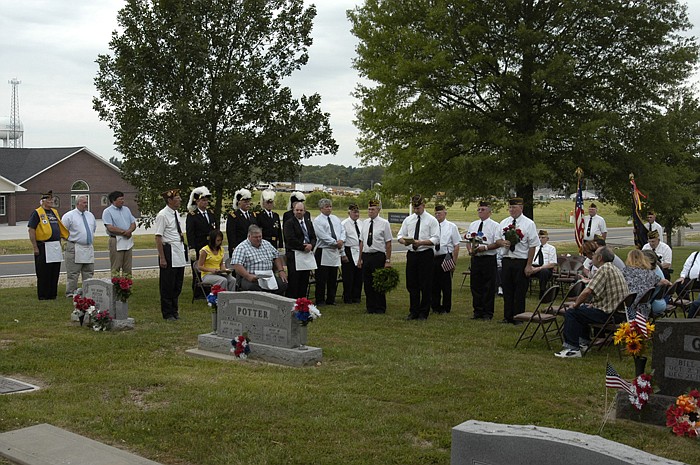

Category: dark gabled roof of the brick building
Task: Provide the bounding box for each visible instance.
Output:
[0,147,119,185]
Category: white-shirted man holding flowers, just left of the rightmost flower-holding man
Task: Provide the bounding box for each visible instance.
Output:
[464,201,501,321]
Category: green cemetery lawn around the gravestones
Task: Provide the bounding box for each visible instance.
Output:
[0,247,700,465]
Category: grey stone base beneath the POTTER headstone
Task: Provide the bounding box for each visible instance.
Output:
[187,333,323,367]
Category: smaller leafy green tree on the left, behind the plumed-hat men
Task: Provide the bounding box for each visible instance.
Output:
[93,0,337,225]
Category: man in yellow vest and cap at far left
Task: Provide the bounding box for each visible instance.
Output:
[27,191,68,300]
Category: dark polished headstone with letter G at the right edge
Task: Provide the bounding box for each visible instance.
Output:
[652,318,700,397]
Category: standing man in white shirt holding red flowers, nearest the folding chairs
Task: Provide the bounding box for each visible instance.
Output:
[496,197,540,325]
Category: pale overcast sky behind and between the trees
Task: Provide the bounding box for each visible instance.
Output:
[0,0,700,166]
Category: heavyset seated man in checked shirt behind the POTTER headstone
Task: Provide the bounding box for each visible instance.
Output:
[231,224,287,295]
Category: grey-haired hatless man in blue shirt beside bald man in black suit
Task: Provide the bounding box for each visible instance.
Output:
[314,199,347,307]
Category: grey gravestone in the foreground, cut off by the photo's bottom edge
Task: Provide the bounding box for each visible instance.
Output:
[450,420,681,465]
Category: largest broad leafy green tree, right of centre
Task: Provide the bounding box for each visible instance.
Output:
[348,0,698,217]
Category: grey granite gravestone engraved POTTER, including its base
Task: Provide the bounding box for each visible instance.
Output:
[188,291,323,366]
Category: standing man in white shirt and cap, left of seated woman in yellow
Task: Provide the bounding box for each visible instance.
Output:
[153,189,187,321]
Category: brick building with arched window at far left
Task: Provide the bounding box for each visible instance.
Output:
[0,147,140,226]
